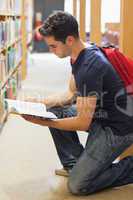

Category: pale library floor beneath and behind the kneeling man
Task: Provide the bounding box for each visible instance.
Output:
[0,54,133,200]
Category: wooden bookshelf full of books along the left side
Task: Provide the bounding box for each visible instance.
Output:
[0,0,33,129]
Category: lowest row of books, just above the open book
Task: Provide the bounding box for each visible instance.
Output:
[0,68,21,119]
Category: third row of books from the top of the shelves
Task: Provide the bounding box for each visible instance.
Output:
[0,43,22,87]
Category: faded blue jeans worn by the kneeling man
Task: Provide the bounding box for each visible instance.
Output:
[49,106,133,195]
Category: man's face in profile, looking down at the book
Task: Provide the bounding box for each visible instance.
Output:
[44,36,71,58]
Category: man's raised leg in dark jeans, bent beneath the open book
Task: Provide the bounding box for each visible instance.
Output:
[48,106,83,169]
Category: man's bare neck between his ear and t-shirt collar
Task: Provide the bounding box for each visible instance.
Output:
[71,40,86,62]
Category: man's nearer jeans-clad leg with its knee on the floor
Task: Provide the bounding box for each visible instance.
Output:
[68,123,133,195]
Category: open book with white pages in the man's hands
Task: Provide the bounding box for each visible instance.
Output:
[5,99,57,119]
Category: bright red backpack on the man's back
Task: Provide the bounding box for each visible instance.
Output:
[100,47,133,95]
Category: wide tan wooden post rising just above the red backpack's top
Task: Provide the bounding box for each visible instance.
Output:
[90,0,102,45]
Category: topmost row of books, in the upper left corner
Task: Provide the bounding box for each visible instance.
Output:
[0,0,22,15]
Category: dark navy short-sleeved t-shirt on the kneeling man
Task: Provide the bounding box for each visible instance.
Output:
[71,45,133,135]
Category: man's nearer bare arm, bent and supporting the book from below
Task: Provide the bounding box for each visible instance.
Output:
[22,96,97,131]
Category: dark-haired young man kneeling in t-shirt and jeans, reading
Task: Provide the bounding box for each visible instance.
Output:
[23,11,133,195]
